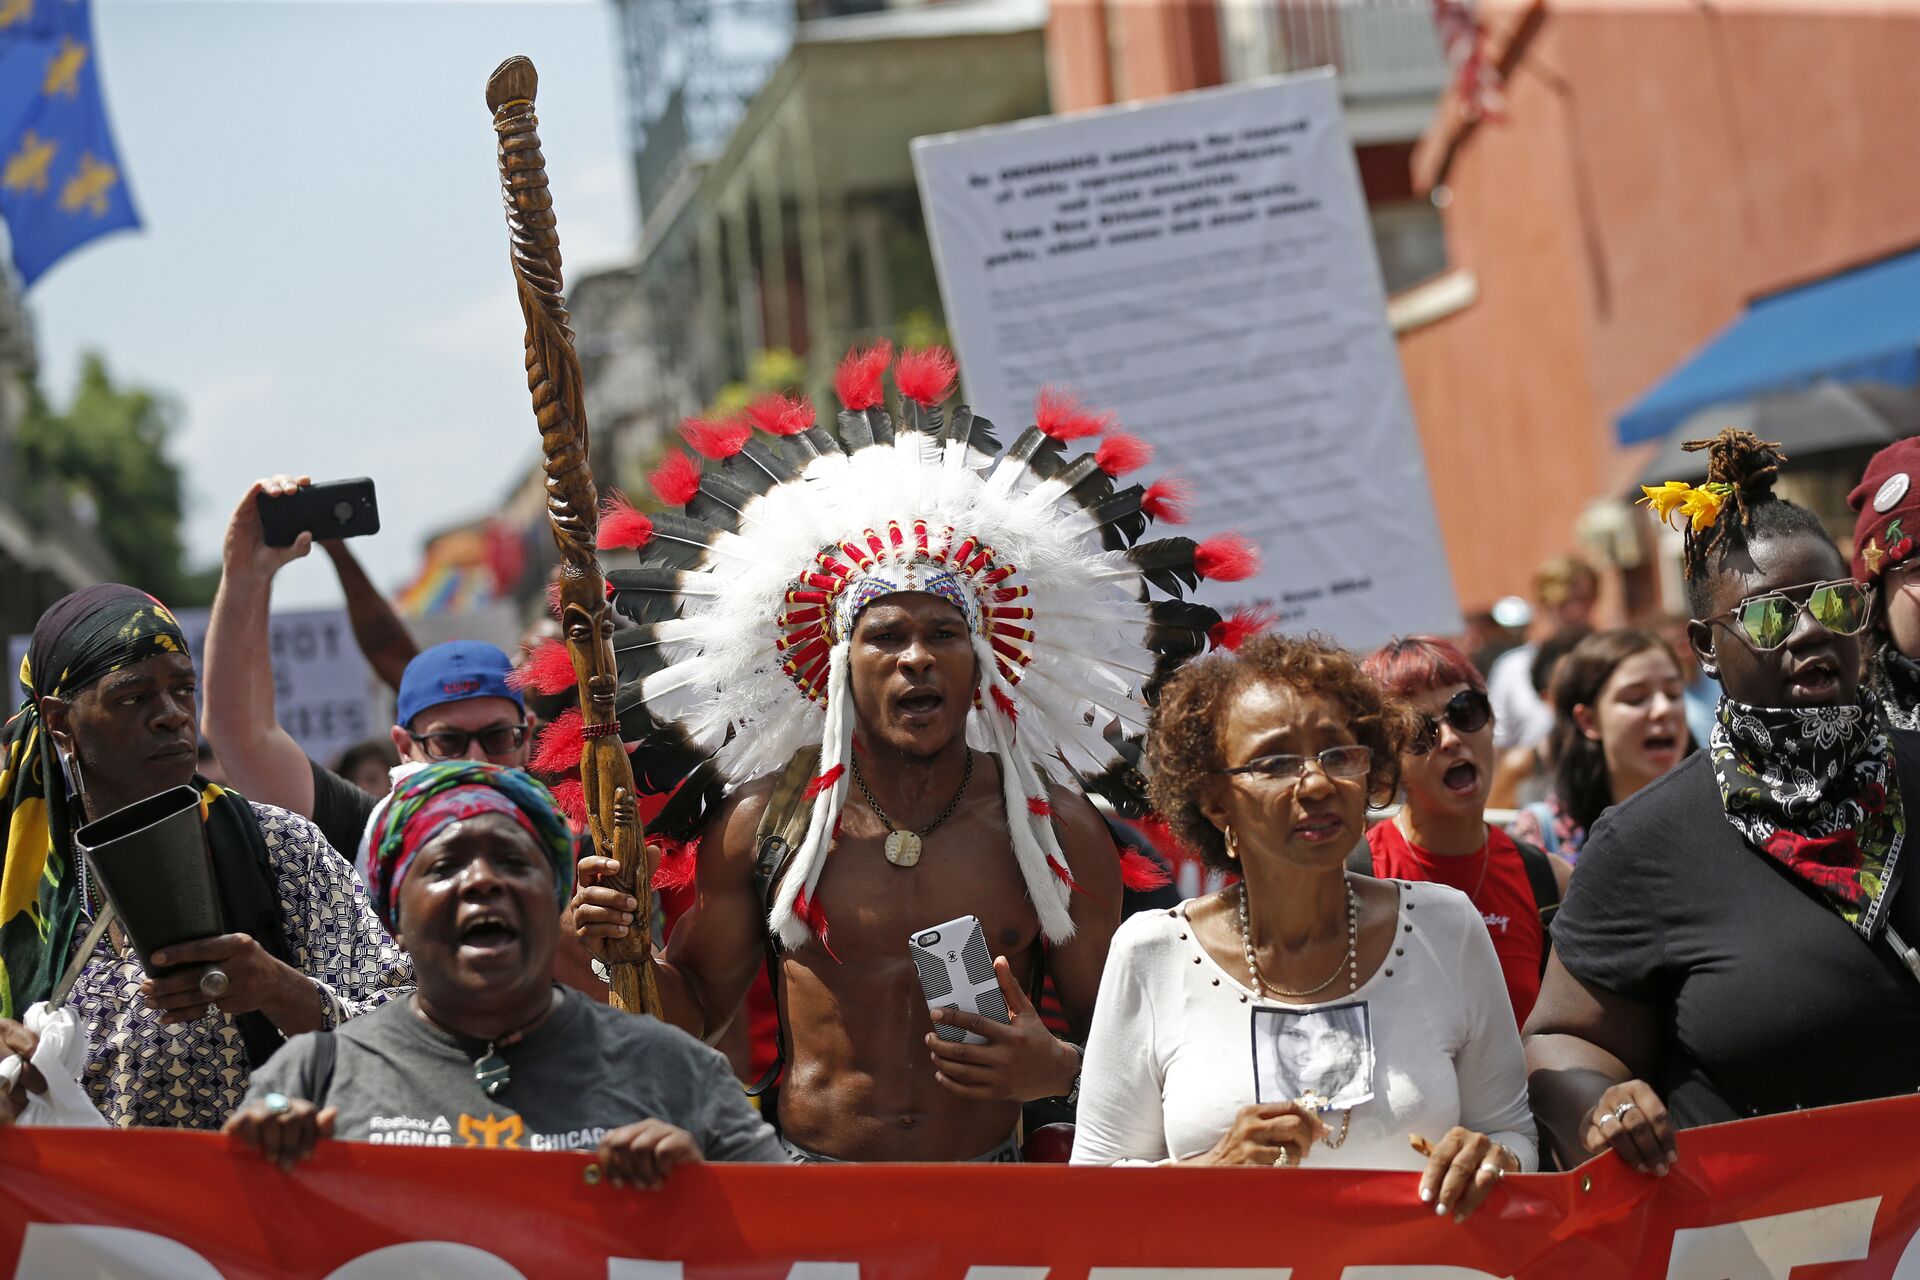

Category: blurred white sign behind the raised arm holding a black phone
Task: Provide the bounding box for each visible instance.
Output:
[8,608,386,764]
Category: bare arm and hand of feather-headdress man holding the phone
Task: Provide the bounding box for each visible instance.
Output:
[927,787,1121,1102]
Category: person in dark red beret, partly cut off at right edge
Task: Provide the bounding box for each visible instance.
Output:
[1847,438,1920,729]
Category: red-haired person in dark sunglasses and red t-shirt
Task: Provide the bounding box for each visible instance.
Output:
[1348,635,1572,1027]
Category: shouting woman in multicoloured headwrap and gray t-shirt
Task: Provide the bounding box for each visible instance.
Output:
[227,762,785,1186]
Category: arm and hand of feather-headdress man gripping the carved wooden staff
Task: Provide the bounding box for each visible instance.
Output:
[574,777,778,1044]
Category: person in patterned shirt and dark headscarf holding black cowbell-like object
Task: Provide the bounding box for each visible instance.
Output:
[0,583,411,1128]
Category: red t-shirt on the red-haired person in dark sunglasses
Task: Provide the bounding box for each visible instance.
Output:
[1367,821,1546,1027]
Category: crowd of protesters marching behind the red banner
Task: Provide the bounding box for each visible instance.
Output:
[0,430,1920,1219]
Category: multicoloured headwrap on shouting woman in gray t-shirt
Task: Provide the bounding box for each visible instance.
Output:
[367,760,574,929]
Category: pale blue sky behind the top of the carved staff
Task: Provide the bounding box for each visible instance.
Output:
[27,0,637,606]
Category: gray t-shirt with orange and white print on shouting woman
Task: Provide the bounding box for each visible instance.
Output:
[246,988,787,1163]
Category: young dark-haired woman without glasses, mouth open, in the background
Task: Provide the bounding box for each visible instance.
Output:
[1509,628,1692,862]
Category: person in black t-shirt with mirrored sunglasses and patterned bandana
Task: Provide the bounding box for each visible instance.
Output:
[1526,430,1920,1174]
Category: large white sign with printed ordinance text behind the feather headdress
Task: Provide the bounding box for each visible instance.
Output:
[914,71,1451,649]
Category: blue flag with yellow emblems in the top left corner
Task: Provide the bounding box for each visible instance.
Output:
[0,0,140,284]
